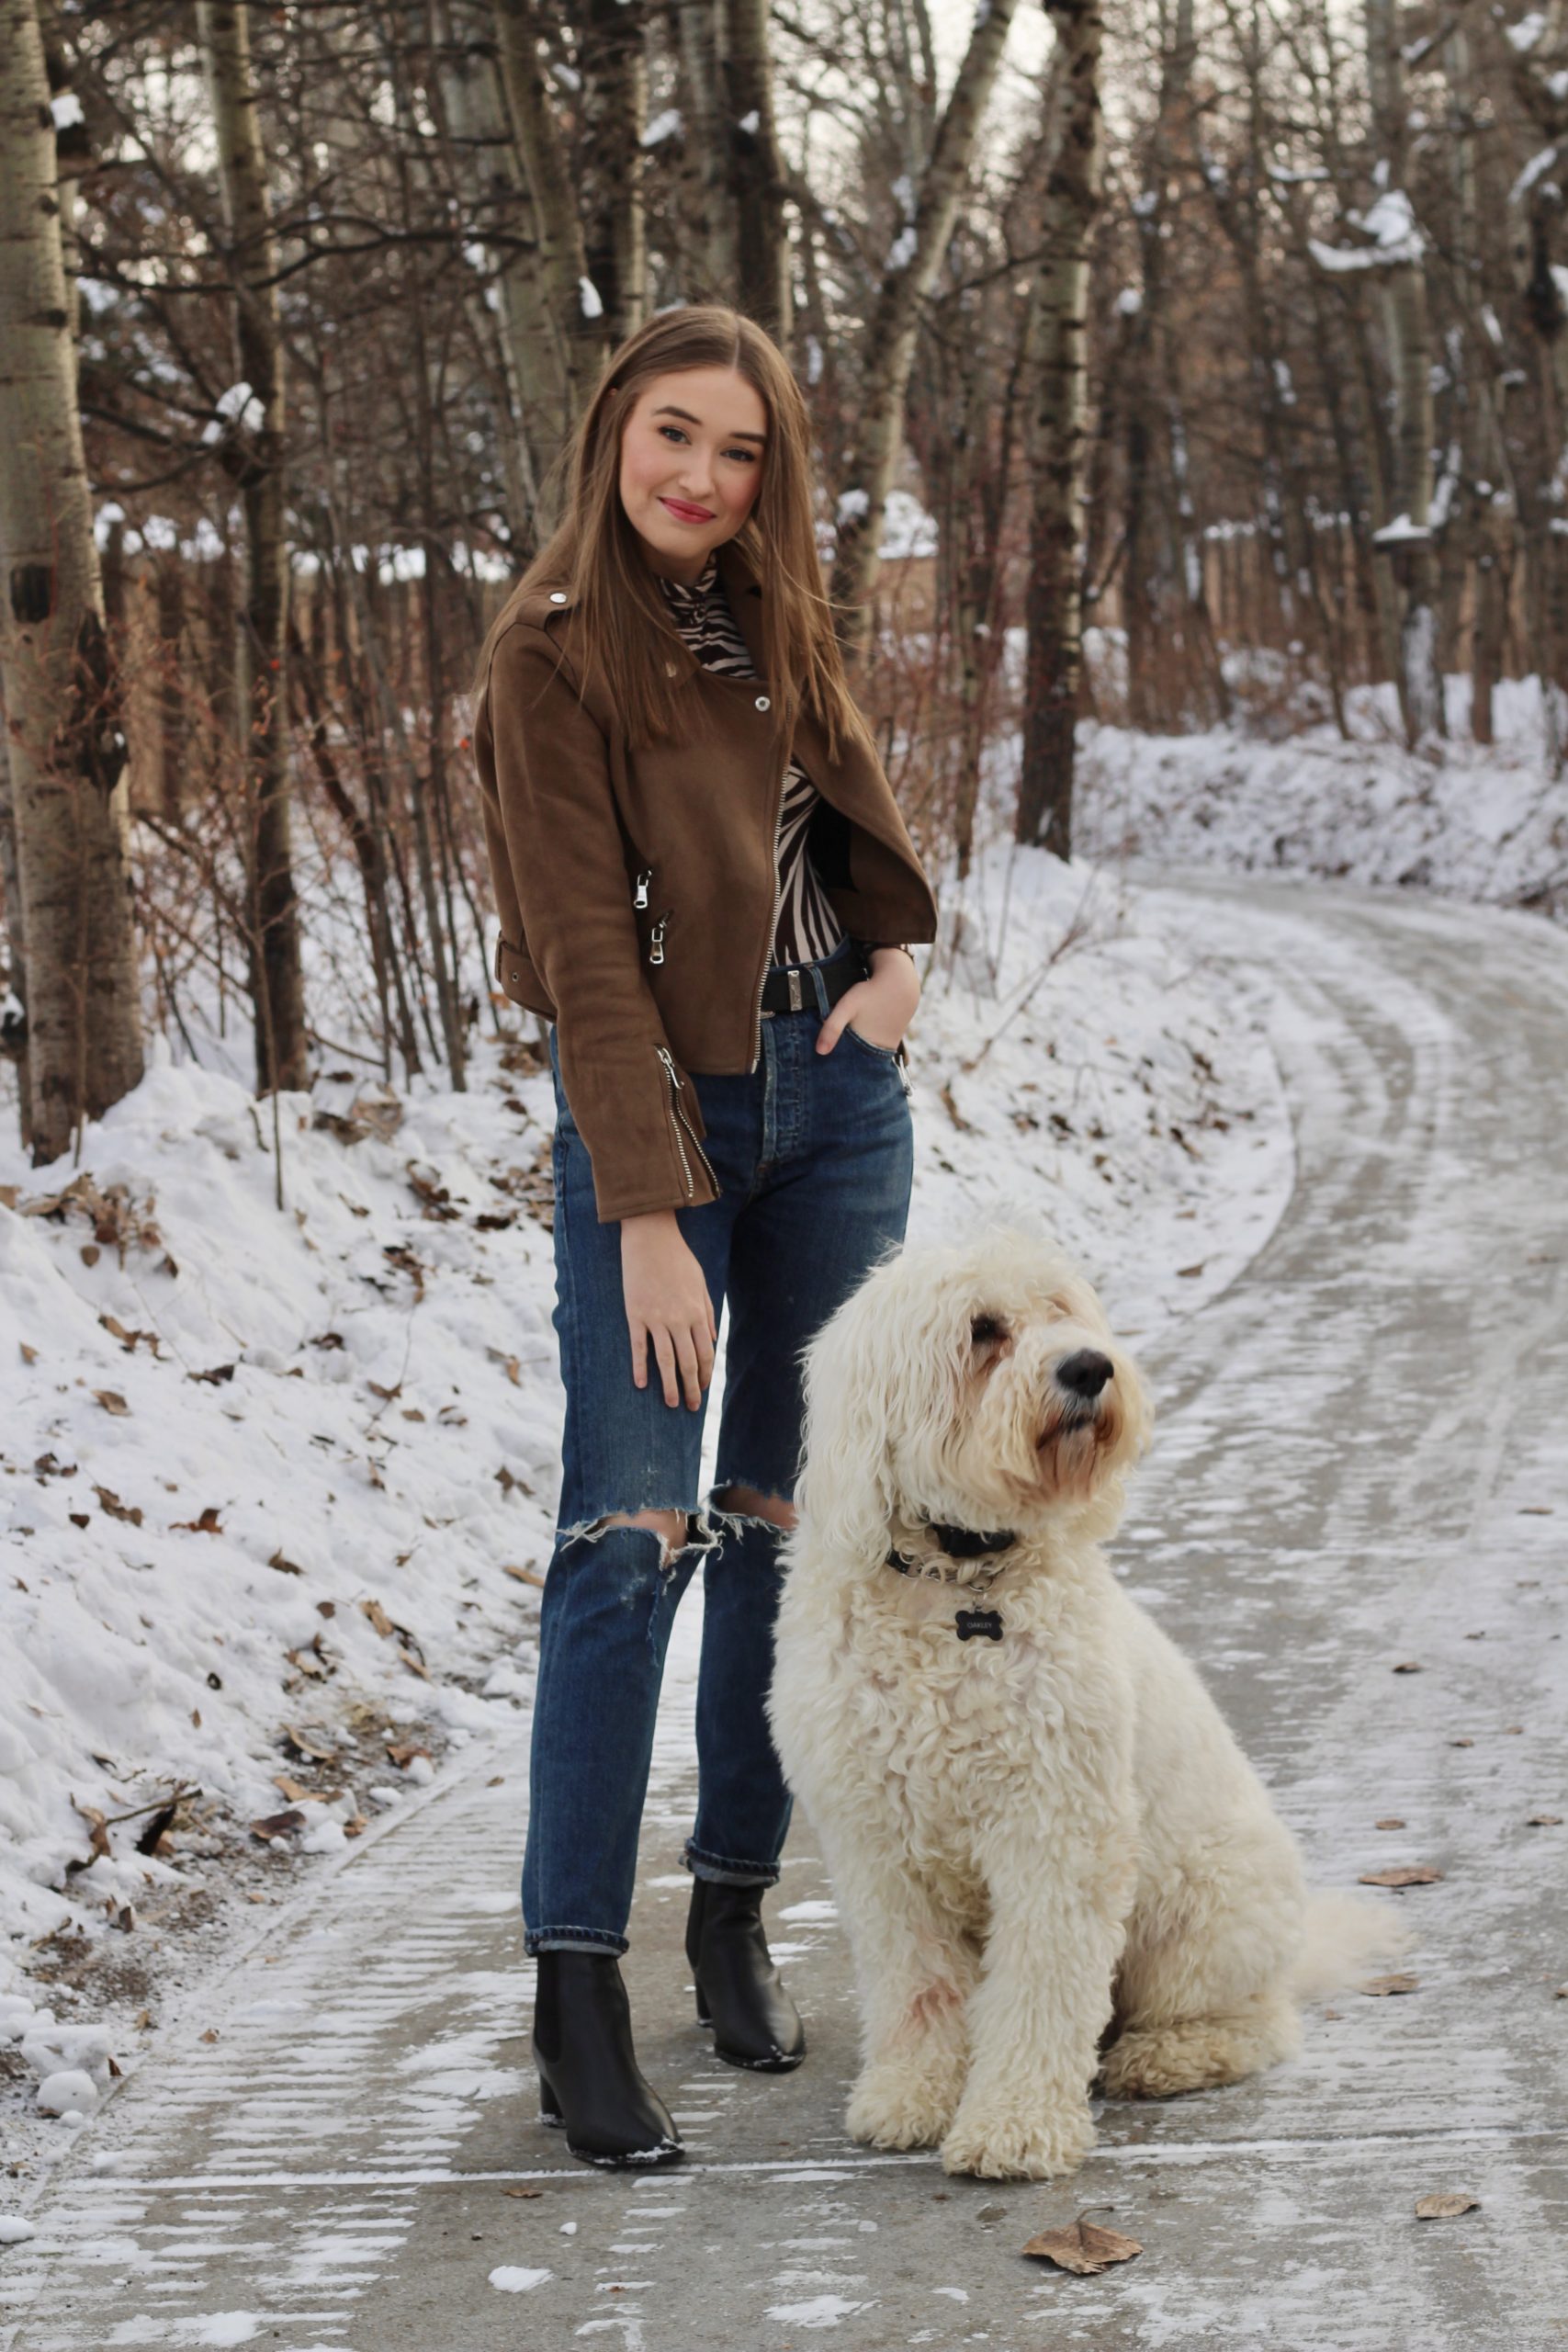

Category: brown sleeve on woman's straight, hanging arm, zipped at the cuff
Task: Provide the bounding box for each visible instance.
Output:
[487,621,717,1223]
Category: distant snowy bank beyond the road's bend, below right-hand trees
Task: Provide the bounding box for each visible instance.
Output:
[1075,656,1568,915]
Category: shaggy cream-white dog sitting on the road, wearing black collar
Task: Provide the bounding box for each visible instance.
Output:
[769,1230,1396,2180]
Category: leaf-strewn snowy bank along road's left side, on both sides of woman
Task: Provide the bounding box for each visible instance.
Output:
[0,847,1291,2159]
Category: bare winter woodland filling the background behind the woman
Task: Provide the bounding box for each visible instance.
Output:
[0,0,1568,1162]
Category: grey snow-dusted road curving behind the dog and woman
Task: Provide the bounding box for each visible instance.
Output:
[0,879,1568,2352]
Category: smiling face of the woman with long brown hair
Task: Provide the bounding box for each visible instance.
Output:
[621,367,766,585]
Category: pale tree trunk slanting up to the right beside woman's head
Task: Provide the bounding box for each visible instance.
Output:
[832,0,1024,651]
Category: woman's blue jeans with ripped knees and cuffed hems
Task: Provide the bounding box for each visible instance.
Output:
[522,941,915,1952]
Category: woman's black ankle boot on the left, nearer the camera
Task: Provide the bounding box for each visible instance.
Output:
[534,1952,686,2166]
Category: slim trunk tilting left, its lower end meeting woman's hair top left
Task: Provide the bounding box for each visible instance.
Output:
[491,0,606,425]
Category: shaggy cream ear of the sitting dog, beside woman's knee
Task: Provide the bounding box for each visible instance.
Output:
[795,1268,908,1574]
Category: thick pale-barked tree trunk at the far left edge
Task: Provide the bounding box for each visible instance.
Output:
[0,0,141,1159]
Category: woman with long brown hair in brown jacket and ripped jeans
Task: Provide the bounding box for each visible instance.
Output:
[475,308,936,2164]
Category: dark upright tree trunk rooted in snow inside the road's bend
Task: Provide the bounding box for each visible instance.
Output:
[1016,0,1105,858]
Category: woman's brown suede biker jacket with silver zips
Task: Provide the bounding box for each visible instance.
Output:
[475,546,936,1223]
